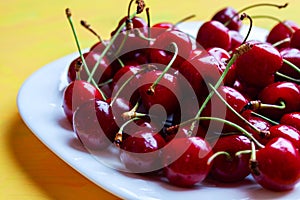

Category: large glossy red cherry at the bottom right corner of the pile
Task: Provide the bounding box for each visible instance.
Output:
[251,137,300,191]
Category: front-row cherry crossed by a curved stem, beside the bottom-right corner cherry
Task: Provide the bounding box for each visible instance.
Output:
[210,135,251,182]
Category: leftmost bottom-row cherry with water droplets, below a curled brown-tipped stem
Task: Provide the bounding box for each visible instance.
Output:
[120,129,165,173]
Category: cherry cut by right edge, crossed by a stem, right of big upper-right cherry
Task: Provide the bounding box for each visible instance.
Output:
[276,48,300,81]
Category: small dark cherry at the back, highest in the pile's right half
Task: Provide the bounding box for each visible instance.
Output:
[212,7,242,31]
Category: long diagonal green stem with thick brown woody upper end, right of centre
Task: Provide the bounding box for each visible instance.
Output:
[190,43,252,131]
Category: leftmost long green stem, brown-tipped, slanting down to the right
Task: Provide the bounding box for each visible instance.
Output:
[65,8,106,100]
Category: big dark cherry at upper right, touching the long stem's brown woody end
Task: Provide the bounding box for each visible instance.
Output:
[236,42,283,88]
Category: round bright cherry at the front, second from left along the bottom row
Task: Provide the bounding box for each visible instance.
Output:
[163,137,212,187]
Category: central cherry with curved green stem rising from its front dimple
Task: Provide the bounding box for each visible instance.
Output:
[139,70,182,114]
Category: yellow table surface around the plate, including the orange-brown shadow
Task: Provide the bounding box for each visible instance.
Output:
[0,0,300,200]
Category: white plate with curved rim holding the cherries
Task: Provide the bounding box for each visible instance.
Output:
[17,22,300,200]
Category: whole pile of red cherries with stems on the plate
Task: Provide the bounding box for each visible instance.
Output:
[63,0,300,191]
